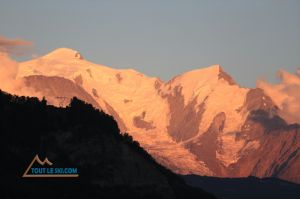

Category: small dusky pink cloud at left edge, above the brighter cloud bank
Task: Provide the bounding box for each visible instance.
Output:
[0,35,32,56]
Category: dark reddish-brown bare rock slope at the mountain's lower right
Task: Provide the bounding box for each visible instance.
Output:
[227,121,300,183]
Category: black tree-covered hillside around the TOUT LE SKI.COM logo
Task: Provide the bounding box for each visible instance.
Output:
[0,91,214,199]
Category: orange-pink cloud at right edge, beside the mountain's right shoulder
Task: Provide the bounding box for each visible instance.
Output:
[257,69,300,124]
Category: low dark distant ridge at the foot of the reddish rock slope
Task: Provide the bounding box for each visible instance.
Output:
[184,175,300,199]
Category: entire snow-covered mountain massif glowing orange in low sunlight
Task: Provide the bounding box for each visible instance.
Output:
[18,48,300,182]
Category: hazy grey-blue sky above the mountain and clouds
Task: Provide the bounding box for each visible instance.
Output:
[0,0,300,86]
